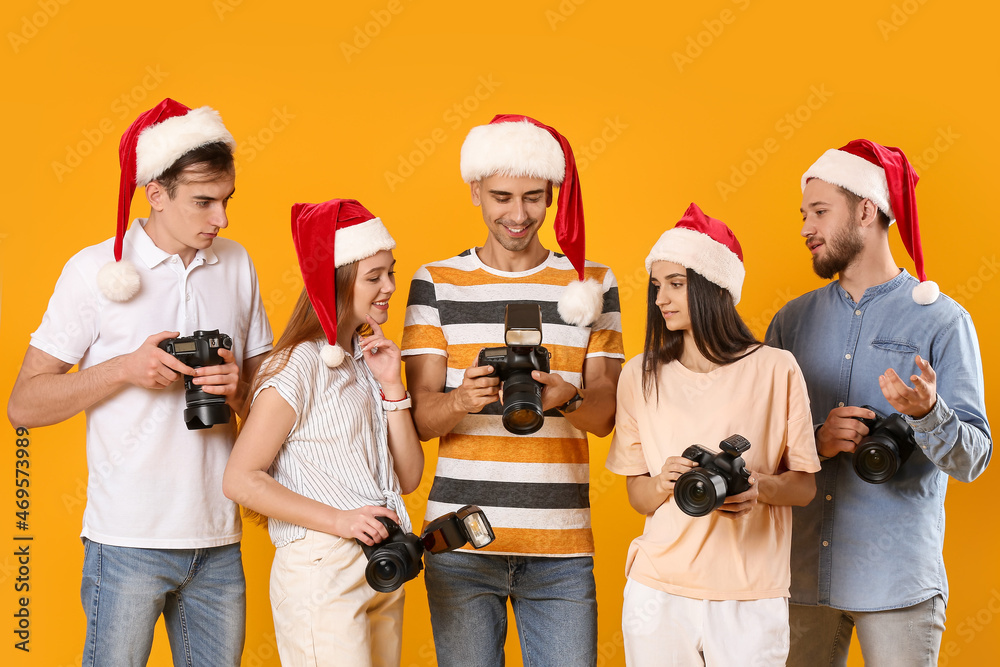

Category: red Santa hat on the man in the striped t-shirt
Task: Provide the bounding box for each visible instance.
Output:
[460,114,604,326]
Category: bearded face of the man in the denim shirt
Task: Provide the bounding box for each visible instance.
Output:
[800,178,864,280]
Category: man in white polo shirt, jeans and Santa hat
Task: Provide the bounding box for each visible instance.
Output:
[7,99,272,665]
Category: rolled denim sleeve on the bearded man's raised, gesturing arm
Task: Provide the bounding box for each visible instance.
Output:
[906,309,993,482]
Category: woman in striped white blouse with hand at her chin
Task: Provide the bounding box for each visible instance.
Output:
[223,200,424,666]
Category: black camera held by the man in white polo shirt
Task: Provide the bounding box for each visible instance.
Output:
[160,329,233,431]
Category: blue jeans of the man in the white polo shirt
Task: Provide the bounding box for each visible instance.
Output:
[80,538,246,667]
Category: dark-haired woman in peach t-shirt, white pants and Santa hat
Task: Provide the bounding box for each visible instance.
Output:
[607,204,819,667]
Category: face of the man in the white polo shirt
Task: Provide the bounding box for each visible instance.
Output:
[145,165,236,265]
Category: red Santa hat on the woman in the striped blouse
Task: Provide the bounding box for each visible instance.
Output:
[292,199,396,368]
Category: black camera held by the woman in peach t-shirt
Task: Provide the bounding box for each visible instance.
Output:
[674,434,750,516]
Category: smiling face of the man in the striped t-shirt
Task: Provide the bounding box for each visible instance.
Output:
[472,174,552,252]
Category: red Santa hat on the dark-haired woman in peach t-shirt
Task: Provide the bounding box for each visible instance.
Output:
[646,203,746,305]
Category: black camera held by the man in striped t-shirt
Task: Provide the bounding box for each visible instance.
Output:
[476,303,552,435]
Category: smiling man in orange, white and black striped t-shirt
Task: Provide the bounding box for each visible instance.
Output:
[403,116,624,667]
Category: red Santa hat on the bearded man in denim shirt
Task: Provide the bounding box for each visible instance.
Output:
[802,139,941,306]
